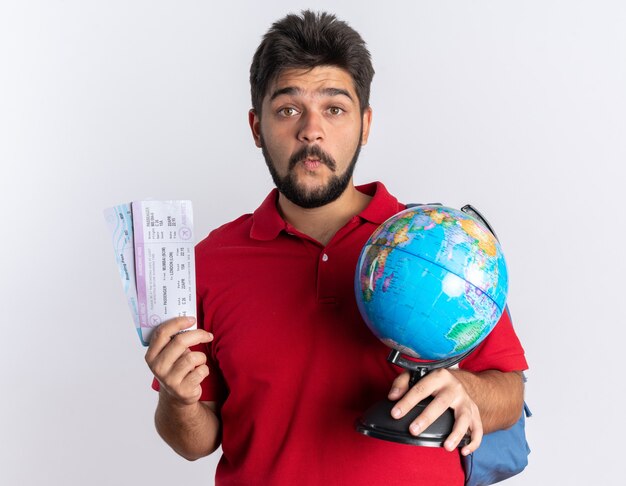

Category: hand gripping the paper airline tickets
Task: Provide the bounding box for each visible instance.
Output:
[146,317,213,405]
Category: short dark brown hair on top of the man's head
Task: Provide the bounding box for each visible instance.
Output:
[250,10,374,115]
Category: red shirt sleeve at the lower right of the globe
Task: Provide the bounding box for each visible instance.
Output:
[459,307,528,372]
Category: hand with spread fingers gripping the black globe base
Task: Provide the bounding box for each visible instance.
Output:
[389,368,483,456]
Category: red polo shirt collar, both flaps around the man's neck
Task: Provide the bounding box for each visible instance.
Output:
[250,182,402,241]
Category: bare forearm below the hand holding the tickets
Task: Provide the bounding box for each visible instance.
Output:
[155,391,220,461]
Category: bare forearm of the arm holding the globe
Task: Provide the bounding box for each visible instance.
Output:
[450,370,524,434]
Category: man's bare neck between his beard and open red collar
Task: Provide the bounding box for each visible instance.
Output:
[278,181,371,246]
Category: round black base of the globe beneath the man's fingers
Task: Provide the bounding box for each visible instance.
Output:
[356,397,470,447]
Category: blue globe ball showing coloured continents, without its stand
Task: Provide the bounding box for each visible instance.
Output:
[355,205,508,360]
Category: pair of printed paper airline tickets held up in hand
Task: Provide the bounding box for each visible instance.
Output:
[104,200,196,346]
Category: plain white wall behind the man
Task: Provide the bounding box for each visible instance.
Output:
[0,0,626,486]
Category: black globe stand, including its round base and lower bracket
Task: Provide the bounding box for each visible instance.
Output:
[355,349,474,447]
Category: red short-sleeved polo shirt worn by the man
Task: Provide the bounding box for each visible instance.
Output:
[154,183,527,486]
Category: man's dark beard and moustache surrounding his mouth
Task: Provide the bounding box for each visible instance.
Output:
[261,132,363,209]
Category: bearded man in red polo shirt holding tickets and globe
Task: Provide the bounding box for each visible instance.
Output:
[146,11,527,486]
